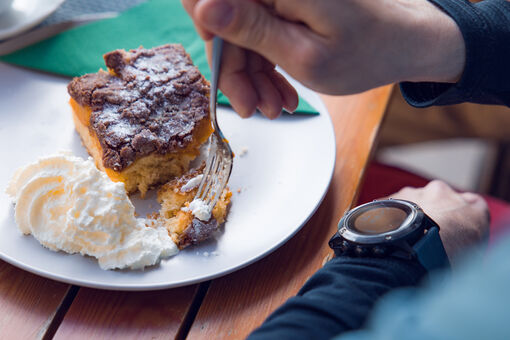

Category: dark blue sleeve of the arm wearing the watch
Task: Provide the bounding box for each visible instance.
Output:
[248,257,426,340]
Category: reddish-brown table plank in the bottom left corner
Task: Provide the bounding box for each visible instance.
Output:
[0,260,70,339]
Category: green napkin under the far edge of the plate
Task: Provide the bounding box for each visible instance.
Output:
[0,0,317,114]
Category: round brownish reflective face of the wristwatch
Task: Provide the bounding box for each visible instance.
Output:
[351,207,409,235]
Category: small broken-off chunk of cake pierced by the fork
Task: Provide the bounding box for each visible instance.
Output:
[158,168,232,249]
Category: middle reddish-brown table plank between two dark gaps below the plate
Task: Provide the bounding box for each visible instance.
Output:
[54,285,199,340]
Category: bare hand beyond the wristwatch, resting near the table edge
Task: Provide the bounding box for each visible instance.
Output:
[390,180,490,265]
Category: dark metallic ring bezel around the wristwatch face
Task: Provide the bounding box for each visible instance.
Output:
[338,199,425,245]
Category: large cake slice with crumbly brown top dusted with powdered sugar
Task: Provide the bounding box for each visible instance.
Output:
[68,45,212,196]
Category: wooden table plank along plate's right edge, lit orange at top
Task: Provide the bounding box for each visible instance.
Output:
[188,86,392,340]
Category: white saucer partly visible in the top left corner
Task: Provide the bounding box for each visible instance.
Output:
[0,0,64,40]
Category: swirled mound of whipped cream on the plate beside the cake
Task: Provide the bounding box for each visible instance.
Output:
[6,153,178,269]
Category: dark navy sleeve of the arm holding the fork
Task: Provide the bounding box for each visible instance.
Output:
[400,0,510,107]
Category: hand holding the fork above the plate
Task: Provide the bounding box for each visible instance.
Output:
[182,0,465,118]
